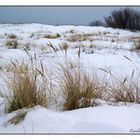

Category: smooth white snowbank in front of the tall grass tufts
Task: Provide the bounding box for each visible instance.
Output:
[0,104,140,133]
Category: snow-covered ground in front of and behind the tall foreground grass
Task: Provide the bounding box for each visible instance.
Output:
[0,24,140,133]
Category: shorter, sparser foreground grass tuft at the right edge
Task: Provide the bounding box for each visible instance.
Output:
[110,77,140,103]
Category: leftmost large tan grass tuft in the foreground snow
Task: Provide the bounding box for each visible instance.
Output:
[3,57,51,112]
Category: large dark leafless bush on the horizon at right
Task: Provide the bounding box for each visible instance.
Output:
[105,8,140,31]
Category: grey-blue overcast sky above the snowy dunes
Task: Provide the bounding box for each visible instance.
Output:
[0,7,140,25]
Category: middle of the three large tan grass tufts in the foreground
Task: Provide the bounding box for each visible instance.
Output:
[59,62,104,110]
